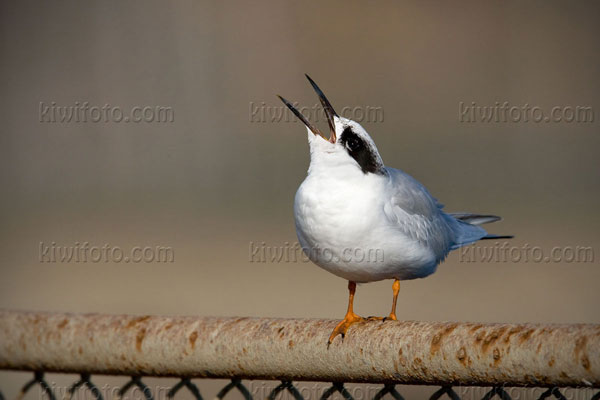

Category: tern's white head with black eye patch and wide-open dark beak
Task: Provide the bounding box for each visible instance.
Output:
[278,75,385,175]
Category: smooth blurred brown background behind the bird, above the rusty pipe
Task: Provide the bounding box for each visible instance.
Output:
[0,1,600,393]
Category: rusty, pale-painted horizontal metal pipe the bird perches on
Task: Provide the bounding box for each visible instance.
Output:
[0,311,600,387]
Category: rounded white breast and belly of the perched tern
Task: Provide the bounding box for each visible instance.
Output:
[294,170,438,282]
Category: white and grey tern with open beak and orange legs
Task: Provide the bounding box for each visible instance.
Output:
[277,75,513,346]
